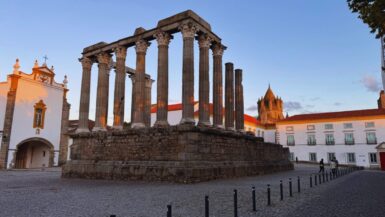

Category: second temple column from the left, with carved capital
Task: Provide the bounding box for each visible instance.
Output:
[93,52,111,131]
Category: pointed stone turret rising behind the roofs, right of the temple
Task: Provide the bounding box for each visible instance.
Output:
[258,85,284,124]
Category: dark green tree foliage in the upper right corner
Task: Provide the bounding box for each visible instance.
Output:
[347,0,385,38]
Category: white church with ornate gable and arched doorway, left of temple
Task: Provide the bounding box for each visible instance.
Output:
[0,60,70,169]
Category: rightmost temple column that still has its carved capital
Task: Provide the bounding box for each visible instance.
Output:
[211,43,226,128]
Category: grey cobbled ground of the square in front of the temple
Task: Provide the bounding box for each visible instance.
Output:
[0,165,376,217]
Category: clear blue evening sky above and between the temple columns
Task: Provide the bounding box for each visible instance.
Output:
[0,0,381,121]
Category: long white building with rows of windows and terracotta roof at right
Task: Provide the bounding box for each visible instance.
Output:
[276,97,385,168]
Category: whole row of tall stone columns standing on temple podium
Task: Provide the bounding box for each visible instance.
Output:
[78,23,243,132]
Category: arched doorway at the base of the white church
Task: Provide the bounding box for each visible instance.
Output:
[14,138,54,169]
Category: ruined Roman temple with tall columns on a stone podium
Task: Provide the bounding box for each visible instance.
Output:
[62,10,293,183]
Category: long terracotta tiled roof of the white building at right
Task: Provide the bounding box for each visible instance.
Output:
[278,109,385,123]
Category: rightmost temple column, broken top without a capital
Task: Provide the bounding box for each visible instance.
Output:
[235,69,245,132]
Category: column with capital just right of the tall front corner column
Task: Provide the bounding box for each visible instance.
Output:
[197,34,212,126]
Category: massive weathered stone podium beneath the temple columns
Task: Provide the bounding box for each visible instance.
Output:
[63,125,293,183]
